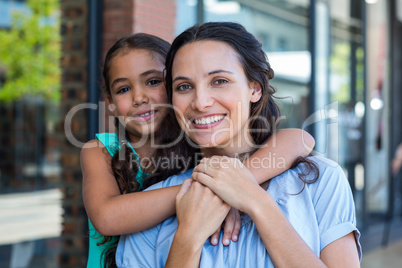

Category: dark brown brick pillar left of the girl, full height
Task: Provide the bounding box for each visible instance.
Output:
[57,0,88,267]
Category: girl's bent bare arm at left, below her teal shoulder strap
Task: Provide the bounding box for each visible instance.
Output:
[81,140,180,236]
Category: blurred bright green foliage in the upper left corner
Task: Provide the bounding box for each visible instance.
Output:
[0,0,61,102]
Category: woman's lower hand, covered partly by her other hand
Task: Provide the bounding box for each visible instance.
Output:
[176,179,230,245]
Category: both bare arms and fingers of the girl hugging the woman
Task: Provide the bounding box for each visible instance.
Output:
[81,129,314,236]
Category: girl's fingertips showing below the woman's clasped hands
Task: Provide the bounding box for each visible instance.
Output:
[211,208,241,246]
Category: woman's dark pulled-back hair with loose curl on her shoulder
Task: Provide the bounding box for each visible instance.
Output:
[165,22,319,186]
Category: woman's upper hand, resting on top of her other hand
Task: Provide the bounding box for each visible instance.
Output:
[192,156,264,213]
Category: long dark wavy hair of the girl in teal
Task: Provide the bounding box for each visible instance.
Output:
[101,33,195,267]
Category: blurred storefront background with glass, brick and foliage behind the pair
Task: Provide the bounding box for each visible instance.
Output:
[0,0,402,267]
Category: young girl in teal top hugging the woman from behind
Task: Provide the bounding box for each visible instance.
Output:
[81,34,314,267]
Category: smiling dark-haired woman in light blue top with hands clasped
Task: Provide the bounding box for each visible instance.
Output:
[116,23,360,267]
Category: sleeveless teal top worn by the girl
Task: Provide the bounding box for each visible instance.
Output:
[87,133,145,268]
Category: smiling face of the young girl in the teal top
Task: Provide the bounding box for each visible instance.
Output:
[108,49,167,142]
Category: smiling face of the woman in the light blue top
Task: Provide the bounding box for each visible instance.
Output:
[172,41,261,155]
